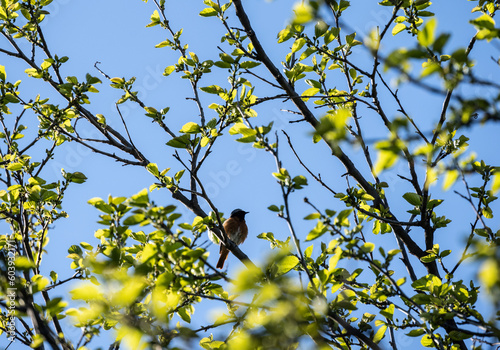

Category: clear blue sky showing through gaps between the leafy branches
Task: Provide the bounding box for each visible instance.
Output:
[0,0,499,349]
